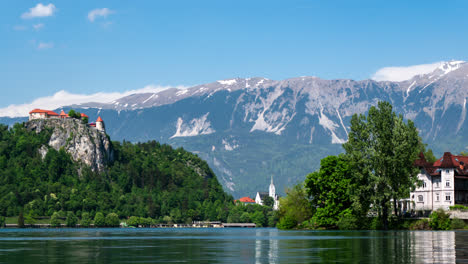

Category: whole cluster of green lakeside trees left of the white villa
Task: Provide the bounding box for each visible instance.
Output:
[278,102,435,229]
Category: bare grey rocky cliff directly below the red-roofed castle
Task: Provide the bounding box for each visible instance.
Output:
[25,118,114,171]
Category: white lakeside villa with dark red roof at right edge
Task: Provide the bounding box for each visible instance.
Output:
[410,152,468,212]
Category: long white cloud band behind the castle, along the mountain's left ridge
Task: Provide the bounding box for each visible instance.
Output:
[0,85,188,117]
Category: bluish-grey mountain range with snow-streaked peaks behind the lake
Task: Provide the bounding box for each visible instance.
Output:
[0,61,468,198]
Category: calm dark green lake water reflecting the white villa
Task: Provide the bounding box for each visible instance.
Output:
[0,228,468,263]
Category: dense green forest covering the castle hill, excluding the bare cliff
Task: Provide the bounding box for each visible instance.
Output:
[0,124,276,226]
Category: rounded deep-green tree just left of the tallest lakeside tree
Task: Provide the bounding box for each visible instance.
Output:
[305,155,352,228]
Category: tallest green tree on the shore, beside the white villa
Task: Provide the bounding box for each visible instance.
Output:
[343,102,423,229]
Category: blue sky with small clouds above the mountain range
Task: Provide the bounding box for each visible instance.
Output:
[0,0,468,116]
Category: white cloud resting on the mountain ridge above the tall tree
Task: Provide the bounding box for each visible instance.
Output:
[371,62,444,82]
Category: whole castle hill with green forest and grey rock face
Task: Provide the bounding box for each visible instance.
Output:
[0,119,232,222]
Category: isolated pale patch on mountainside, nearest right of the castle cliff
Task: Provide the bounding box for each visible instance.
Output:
[170,112,216,138]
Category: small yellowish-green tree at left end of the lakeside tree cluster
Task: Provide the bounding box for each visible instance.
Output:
[278,184,312,228]
